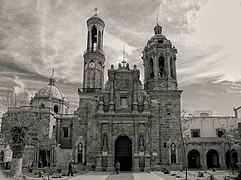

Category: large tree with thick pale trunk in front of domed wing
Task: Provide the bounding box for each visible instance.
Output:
[1,89,45,176]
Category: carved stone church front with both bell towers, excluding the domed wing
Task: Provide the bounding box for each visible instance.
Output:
[72,14,183,171]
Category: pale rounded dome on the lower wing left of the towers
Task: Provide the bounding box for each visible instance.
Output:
[35,78,65,99]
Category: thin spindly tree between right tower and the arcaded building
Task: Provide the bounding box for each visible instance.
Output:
[178,110,193,180]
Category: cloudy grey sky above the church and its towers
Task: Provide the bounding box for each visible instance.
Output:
[0,0,241,116]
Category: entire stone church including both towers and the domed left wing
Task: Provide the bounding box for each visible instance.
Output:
[0,14,183,171]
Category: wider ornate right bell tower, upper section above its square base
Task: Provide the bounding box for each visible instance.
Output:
[142,23,177,90]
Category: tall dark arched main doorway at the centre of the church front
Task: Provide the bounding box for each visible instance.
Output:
[115,136,132,171]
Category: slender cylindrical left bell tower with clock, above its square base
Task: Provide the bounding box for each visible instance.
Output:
[83,8,105,92]
